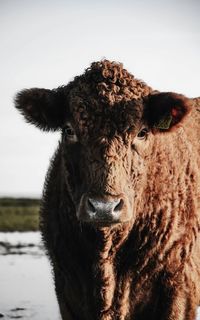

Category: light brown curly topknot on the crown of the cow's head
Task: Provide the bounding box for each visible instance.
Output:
[69,60,152,106]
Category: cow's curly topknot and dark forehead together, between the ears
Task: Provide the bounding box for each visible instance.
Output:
[65,60,152,139]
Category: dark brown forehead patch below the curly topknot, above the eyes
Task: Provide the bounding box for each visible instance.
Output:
[70,97,144,137]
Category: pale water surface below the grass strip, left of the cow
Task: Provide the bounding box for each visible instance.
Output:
[0,232,60,320]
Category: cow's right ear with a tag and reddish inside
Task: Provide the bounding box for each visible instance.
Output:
[145,92,193,133]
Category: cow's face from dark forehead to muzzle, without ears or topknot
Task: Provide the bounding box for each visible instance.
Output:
[62,96,150,224]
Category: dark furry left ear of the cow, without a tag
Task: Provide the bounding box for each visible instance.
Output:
[15,87,68,131]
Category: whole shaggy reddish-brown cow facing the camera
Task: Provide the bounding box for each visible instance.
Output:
[15,60,200,320]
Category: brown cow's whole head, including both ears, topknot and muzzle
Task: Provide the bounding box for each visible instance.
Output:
[16,60,191,225]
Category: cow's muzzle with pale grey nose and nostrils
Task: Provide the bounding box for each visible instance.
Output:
[77,194,131,225]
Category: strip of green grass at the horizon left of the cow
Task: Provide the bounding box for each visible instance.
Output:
[0,198,40,231]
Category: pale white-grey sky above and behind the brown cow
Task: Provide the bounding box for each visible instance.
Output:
[0,0,200,196]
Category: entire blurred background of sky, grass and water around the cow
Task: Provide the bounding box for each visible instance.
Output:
[0,0,200,320]
